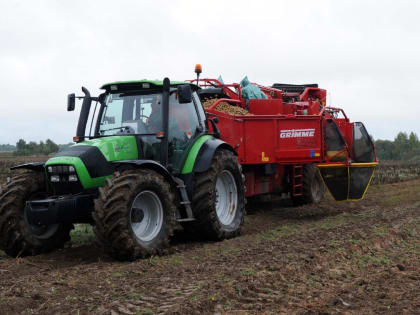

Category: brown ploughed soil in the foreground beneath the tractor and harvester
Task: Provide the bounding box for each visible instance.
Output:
[0,157,420,314]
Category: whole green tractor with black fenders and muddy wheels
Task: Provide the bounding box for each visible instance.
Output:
[0,78,245,260]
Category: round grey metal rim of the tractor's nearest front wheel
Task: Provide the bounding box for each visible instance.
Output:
[130,190,163,242]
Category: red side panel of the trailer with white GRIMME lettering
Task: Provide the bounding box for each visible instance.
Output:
[207,111,323,164]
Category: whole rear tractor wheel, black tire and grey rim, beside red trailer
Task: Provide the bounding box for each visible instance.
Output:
[186,150,245,240]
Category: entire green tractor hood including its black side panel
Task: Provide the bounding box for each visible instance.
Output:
[46,136,138,189]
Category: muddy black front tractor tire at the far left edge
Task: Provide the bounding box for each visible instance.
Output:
[0,171,73,257]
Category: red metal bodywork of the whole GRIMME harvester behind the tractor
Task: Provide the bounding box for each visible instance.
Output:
[191,79,370,197]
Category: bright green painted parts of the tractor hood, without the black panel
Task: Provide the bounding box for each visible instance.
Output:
[45,136,139,189]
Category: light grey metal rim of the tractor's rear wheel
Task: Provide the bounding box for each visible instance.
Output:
[216,170,238,225]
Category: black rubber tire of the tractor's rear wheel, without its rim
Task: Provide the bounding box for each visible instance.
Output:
[184,150,245,241]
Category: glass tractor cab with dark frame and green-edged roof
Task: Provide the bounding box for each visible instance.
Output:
[70,80,207,173]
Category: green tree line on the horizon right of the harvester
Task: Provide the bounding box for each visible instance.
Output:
[375,132,420,161]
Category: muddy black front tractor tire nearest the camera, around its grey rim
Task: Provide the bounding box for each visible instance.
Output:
[93,169,176,260]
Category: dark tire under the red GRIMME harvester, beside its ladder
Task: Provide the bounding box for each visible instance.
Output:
[292,164,325,206]
